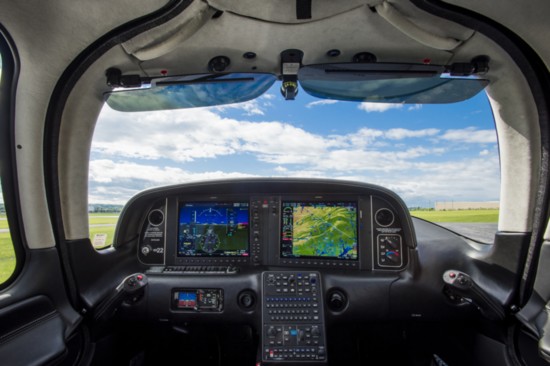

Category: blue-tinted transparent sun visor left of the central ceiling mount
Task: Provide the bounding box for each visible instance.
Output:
[105,73,277,112]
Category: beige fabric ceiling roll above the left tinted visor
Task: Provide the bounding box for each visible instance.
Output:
[122,1,216,61]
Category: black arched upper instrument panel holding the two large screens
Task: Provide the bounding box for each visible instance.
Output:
[117,179,416,271]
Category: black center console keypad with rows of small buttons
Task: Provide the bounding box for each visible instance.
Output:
[262,271,327,363]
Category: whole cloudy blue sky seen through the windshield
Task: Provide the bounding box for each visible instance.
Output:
[89,82,500,207]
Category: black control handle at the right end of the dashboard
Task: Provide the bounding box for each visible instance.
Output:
[443,269,506,320]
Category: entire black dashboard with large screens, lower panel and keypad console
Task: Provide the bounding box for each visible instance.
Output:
[110,179,489,364]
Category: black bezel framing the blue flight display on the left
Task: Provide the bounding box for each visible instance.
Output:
[175,199,251,262]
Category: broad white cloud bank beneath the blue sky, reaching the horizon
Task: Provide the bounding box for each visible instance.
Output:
[90,104,499,203]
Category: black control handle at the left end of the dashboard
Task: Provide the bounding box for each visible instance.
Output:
[94,273,148,321]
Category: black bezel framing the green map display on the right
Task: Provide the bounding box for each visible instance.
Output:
[278,197,361,263]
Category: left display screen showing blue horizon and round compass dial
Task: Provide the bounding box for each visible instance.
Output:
[177,202,249,257]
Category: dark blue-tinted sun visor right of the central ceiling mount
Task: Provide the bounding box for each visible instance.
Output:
[298,63,489,104]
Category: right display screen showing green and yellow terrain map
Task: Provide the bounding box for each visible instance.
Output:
[281,201,357,260]
